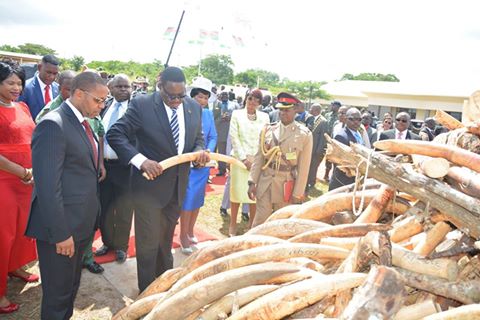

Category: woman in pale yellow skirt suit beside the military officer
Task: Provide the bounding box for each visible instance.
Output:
[228,89,270,236]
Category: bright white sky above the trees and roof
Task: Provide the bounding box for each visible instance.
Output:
[0,0,480,87]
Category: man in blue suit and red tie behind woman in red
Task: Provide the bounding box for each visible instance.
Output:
[18,54,60,120]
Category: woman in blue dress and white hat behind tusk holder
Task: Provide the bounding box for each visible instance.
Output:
[180,77,217,255]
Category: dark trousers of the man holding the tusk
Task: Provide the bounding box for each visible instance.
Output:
[135,190,181,292]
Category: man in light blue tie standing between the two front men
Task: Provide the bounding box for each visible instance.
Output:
[95,74,133,263]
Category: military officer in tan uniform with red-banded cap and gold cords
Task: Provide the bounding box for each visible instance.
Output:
[248,92,313,226]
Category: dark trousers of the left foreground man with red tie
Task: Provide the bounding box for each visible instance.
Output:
[37,234,93,320]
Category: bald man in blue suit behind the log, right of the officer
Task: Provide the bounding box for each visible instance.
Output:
[328,108,365,190]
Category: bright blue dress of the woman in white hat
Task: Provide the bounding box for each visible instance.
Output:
[182,108,217,211]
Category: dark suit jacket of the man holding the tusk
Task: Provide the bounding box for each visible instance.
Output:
[107,92,204,208]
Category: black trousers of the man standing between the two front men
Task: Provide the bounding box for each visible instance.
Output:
[100,161,133,251]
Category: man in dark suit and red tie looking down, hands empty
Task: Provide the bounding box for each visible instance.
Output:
[26,72,108,320]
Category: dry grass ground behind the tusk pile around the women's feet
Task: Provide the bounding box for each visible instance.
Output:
[196,182,328,239]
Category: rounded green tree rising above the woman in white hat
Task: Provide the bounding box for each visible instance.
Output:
[200,54,233,84]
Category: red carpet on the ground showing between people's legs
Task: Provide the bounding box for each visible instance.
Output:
[93,168,226,263]
